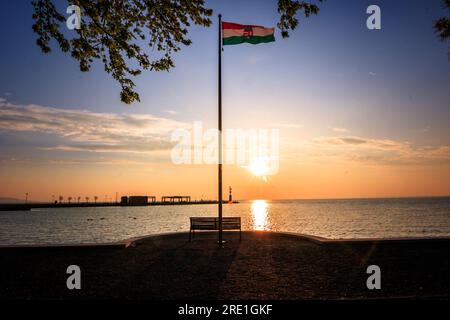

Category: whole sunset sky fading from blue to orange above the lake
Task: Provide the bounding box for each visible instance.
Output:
[0,1,450,201]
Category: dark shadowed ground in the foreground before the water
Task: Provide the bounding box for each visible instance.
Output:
[0,232,450,300]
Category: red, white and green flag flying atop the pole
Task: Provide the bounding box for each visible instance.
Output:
[222,22,275,46]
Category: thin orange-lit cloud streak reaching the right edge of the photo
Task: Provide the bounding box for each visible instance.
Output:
[313,136,450,165]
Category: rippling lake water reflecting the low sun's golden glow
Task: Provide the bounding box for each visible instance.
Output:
[0,198,450,245]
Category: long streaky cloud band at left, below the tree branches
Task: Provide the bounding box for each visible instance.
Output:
[0,99,189,153]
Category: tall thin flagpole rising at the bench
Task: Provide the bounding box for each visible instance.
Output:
[217,14,223,247]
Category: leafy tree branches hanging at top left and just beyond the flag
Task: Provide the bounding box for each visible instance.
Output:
[32,0,322,103]
